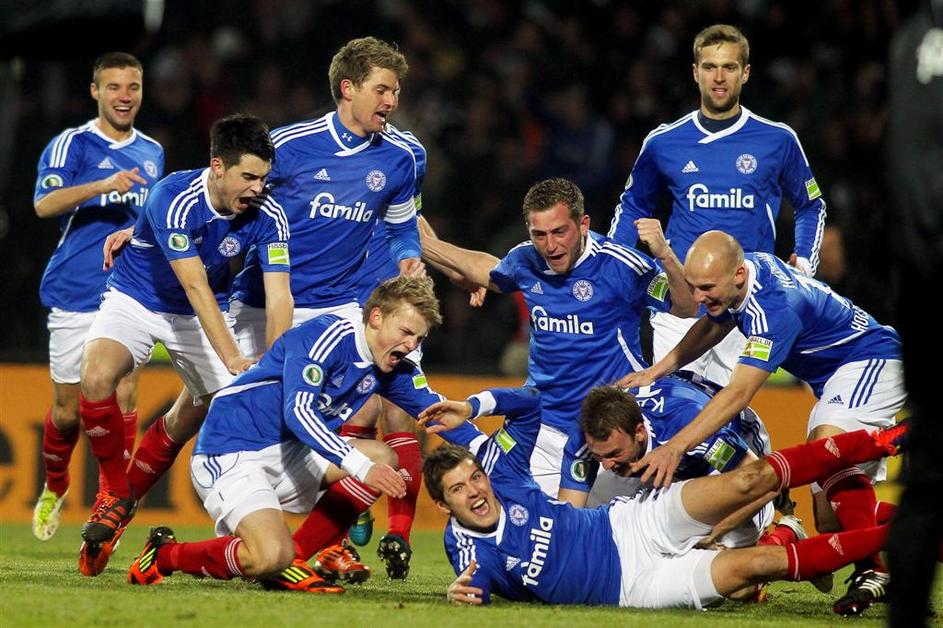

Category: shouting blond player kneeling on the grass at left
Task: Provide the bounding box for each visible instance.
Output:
[128,277,450,593]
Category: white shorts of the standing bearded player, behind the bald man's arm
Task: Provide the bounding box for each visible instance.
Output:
[651,312,747,386]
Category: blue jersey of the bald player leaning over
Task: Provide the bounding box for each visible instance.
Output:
[712,253,901,397]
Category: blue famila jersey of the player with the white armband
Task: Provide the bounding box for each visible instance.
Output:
[233,112,420,308]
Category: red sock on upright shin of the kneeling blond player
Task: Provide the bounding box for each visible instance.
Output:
[292,477,380,560]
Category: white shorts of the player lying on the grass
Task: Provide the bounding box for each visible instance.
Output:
[609,482,722,609]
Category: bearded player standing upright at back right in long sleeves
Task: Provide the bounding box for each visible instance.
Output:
[609,24,825,385]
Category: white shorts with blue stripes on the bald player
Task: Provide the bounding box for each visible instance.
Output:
[808,359,907,492]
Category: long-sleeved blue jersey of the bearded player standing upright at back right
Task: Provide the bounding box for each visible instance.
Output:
[609,107,825,273]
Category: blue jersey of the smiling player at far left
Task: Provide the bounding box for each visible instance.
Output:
[33,120,164,312]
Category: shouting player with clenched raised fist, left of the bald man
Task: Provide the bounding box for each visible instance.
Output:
[422,179,696,505]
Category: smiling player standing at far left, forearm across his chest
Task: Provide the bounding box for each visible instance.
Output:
[33,52,164,541]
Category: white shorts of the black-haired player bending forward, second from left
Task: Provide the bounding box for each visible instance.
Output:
[85,290,234,399]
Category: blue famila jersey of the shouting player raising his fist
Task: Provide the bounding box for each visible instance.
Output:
[491,232,671,432]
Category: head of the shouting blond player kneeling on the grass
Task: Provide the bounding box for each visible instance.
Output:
[363,275,442,373]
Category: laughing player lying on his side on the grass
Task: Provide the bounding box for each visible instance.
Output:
[421,395,907,609]
